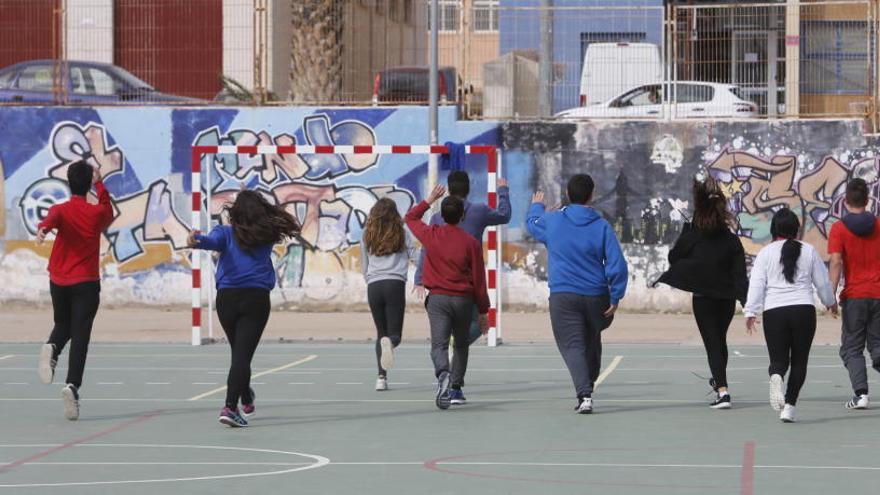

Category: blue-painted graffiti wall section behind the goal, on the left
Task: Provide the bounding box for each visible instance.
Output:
[0,108,502,306]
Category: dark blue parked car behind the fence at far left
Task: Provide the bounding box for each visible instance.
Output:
[0,60,201,104]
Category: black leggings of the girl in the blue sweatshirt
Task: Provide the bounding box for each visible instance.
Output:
[217,289,272,409]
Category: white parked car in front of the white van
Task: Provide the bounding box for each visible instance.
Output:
[556,81,758,119]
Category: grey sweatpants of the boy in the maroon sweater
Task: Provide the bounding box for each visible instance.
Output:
[425,294,474,387]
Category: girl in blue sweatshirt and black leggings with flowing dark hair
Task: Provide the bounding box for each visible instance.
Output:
[189,191,300,428]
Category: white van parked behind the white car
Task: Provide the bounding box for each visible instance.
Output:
[580,43,663,106]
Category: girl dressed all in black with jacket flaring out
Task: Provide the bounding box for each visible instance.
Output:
[655,178,749,409]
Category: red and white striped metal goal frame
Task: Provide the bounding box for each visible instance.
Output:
[190,145,502,347]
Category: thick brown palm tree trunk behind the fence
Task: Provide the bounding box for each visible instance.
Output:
[289,0,348,102]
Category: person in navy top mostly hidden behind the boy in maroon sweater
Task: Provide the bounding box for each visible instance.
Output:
[413,170,512,344]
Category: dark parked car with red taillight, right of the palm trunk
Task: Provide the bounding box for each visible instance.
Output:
[373,66,459,104]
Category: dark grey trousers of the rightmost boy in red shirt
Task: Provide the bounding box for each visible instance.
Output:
[840,299,880,393]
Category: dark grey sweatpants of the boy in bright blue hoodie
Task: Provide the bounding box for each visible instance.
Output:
[550,292,611,398]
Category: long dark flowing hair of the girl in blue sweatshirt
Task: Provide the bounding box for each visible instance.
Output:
[224,191,300,250]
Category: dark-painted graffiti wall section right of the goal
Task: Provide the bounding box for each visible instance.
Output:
[502,121,880,311]
